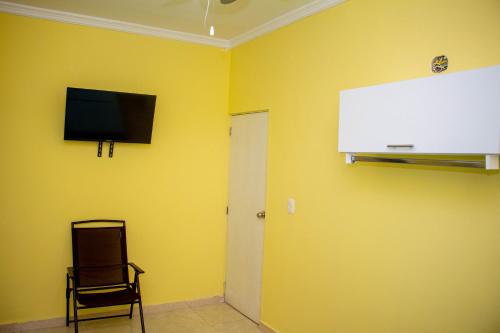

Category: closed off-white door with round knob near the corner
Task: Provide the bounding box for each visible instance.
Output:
[225,112,267,322]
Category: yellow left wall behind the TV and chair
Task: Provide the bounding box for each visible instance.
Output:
[0,14,230,324]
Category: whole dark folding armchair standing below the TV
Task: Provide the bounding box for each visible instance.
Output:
[66,220,145,333]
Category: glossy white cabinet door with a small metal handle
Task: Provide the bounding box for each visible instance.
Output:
[339,66,500,154]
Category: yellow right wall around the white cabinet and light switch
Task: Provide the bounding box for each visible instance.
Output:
[230,0,500,333]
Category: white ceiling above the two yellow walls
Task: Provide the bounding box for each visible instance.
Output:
[0,0,342,47]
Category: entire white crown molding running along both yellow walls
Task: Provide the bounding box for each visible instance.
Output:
[0,0,346,49]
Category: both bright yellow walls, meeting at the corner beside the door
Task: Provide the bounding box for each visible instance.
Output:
[0,0,500,333]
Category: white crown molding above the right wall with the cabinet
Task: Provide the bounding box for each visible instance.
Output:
[229,0,346,47]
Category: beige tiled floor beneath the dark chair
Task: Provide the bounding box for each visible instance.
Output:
[22,303,262,333]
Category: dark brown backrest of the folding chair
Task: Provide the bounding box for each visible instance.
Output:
[71,220,129,288]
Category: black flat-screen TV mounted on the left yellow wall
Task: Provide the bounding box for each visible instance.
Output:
[64,88,156,143]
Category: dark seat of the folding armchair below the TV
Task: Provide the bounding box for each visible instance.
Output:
[76,288,139,307]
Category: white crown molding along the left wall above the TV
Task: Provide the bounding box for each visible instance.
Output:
[0,1,230,48]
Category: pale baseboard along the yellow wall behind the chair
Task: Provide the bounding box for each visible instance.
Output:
[0,296,224,333]
